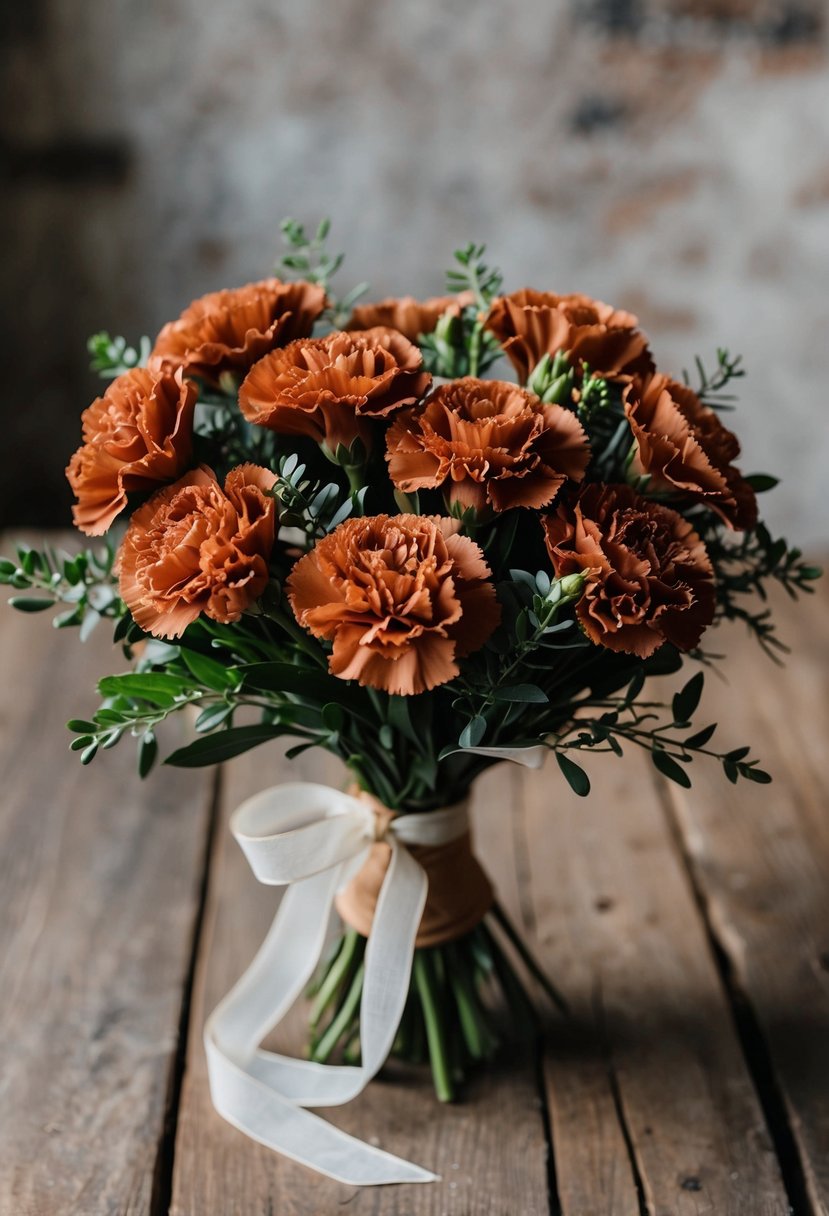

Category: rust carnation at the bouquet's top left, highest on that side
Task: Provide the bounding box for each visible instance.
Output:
[150,278,327,383]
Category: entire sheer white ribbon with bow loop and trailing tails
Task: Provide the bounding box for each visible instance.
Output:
[204,783,468,1186]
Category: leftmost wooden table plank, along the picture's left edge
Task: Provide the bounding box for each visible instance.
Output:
[0,586,216,1216]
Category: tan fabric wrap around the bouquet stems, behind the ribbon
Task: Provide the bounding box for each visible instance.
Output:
[337,790,495,946]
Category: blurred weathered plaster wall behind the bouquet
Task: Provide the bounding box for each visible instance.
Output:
[0,0,829,544]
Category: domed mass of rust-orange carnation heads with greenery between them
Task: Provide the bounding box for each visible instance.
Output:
[53,234,806,778]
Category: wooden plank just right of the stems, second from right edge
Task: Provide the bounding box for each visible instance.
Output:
[524,754,789,1216]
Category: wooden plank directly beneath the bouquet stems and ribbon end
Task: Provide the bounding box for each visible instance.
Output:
[171,747,549,1216]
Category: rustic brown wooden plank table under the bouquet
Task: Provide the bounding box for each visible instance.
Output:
[0,547,829,1216]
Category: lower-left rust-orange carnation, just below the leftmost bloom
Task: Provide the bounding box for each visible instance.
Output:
[119,465,276,637]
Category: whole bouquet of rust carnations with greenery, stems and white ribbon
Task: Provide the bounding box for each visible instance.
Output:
[0,220,819,1182]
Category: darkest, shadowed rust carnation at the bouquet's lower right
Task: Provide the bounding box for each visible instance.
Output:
[543,485,716,659]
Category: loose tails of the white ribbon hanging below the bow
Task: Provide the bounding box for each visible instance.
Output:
[204,846,436,1186]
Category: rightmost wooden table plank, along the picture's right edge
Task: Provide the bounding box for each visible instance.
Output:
[666,586,829,1216]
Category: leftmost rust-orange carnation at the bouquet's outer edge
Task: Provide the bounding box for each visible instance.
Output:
[66,367,197,536]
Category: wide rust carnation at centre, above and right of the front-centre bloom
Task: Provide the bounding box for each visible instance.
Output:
[387,376,590,511]
